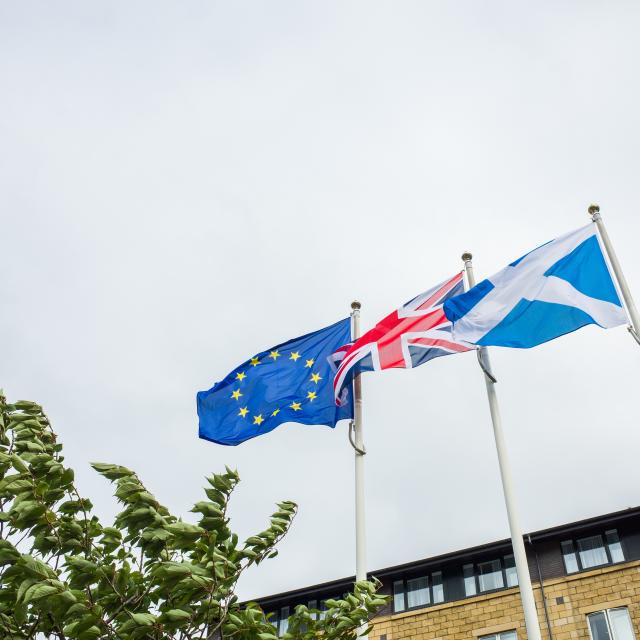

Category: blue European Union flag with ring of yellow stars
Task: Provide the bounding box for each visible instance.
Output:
[197,318,353,445]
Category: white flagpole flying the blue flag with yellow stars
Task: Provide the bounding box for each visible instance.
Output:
[349,300,367,582]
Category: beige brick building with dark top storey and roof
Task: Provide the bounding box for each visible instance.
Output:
[258,507,640,640]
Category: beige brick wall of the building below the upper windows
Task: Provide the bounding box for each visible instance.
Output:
[369,561,640,640]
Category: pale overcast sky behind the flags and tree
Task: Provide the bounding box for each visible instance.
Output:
[0,0,640,597]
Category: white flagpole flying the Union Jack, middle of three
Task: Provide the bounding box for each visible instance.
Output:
[462,253,541,640]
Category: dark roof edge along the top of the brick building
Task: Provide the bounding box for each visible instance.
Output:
[252,506,640,605]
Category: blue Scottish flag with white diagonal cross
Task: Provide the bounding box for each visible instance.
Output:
[444,224,627,348]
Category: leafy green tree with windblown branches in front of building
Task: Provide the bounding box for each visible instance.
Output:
[0,392,385,640]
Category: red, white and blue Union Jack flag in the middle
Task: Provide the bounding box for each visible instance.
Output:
[333,272,470,405]
